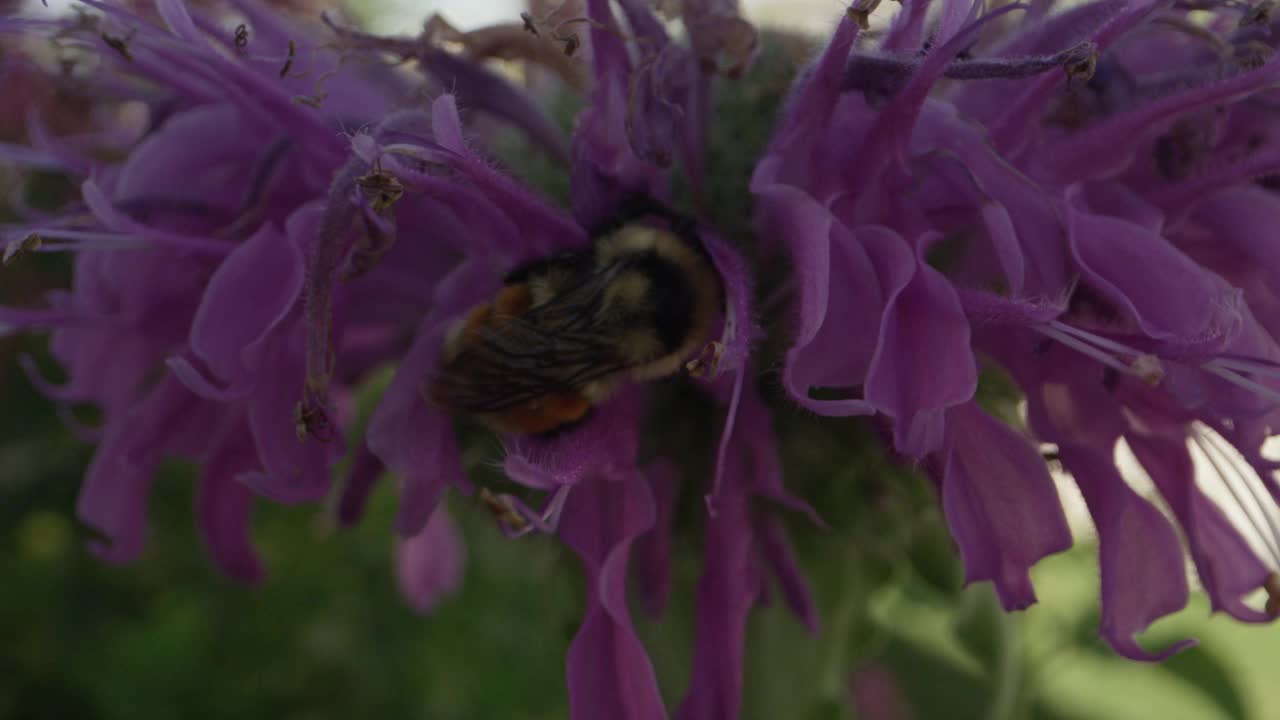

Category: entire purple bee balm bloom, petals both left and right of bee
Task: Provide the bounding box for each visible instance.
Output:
[12,0,1280,720]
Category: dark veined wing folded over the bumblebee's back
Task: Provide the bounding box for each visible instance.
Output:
[430,269,631,413]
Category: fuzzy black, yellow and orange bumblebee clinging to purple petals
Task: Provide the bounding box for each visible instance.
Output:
[426,201,723,434]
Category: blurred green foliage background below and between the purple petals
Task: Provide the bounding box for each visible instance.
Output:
[0,0,1280,720]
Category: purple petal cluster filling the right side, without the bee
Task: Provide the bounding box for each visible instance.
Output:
[751,1,1280,659]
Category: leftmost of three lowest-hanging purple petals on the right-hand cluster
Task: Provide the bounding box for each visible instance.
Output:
[942,402,1071,610]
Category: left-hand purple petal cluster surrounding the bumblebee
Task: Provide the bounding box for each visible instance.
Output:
[0,0,818,720]
